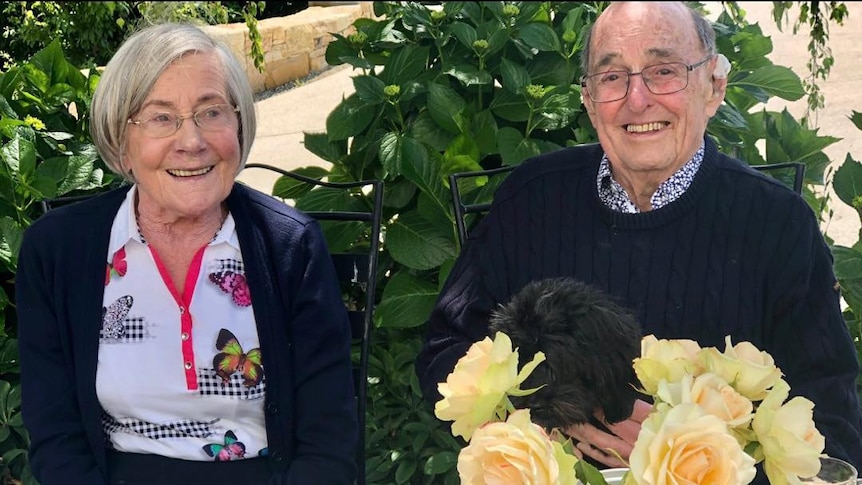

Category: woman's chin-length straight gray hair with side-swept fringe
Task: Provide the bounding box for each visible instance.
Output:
[90,23,257,182]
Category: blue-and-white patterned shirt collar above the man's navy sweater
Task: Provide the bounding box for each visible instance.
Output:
[596,143,705,214]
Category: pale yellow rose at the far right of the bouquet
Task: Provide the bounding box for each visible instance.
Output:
[751,380,826,485]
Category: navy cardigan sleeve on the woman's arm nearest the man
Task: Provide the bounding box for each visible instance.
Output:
[286,223,359,485]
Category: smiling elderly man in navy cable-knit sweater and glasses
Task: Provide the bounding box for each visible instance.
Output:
[416,2,862,474]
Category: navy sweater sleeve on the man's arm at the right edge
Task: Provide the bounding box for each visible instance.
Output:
[766,202,862,469]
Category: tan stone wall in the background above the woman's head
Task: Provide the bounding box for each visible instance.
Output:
[205,2,374,93]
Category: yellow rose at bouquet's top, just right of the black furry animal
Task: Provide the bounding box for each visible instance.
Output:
[634,335,700,395]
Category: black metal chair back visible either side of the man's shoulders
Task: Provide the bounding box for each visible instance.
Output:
[449,162,805,246]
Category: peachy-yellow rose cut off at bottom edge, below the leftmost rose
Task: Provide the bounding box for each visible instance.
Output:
[458,409,578,485]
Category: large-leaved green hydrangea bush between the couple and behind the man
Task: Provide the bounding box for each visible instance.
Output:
[284,2,862,484]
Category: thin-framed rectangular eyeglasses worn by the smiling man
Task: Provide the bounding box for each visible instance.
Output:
[581,55,713,103]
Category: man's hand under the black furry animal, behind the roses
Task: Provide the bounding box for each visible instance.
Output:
[566,400,652,468]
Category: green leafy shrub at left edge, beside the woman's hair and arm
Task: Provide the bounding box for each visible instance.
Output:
[0,40,112,483]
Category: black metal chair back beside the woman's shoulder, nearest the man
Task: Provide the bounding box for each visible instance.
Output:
[244,163,383,485]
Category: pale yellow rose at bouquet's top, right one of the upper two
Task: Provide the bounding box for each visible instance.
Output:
[701,336,781,401]
